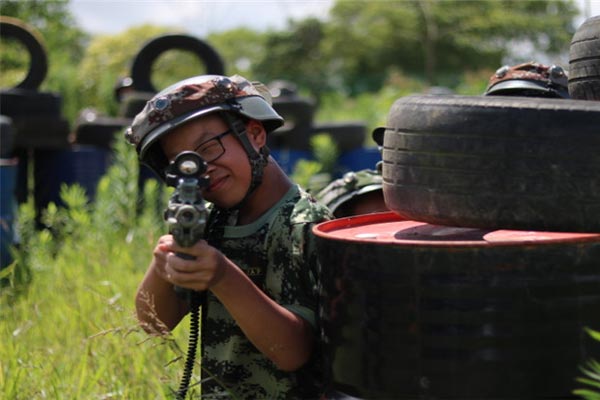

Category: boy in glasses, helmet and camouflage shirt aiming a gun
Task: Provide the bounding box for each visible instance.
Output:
[126,75,330,399]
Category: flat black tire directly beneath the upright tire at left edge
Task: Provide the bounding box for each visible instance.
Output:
[0,89,62,118]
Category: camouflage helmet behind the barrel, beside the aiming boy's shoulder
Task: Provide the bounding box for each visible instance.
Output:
[315,169,383,219]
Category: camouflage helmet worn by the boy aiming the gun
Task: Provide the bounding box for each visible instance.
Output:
[125,75,283,177]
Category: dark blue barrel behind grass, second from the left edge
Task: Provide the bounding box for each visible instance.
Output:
[34,146,111,212]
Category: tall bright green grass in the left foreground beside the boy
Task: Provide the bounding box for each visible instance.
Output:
[0,140,198,400]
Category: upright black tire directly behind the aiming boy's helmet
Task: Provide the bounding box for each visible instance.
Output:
[131,34,225,93]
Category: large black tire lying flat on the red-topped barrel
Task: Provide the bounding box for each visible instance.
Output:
[382,95,600,232]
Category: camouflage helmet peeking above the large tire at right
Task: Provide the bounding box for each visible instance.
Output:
[484,62,570,99]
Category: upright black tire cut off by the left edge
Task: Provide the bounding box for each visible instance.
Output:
[0,17,48,90]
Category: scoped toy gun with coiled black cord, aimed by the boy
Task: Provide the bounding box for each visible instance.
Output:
[164,151,209,400]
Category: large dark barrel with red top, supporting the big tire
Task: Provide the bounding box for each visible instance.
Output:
[314,213,600,399]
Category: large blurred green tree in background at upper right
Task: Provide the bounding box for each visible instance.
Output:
[324,0,577,93]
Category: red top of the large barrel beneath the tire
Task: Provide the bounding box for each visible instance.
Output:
[313,212,600,247]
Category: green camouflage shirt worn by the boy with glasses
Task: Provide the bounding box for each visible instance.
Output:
[202,186,330,399]
